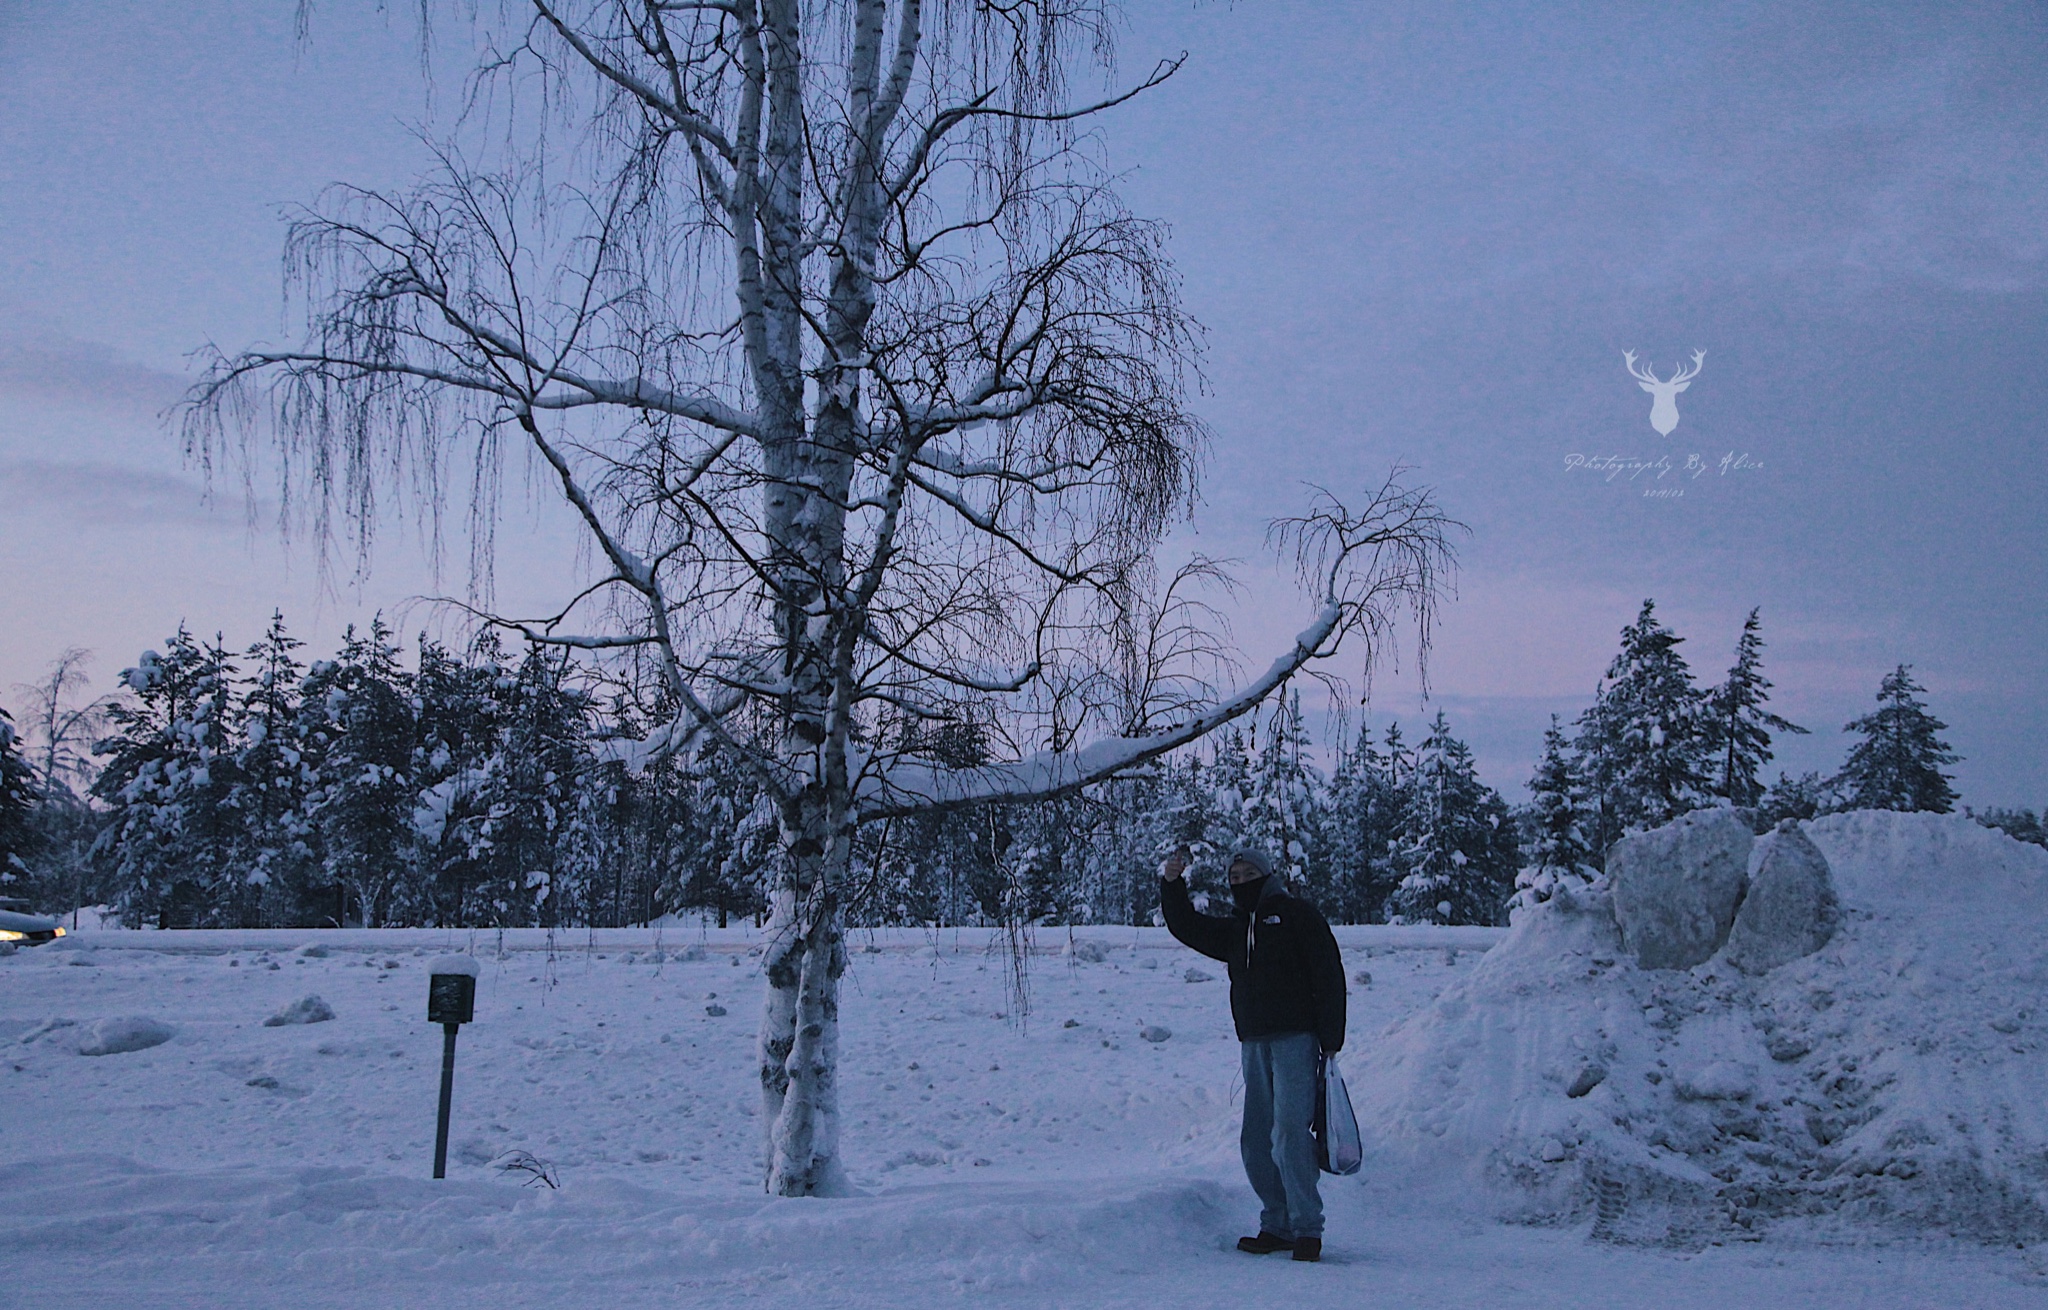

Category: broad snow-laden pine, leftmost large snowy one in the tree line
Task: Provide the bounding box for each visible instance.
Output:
[92,624,245,927]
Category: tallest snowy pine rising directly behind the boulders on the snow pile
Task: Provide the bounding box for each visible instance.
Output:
[1575,600,1710,852]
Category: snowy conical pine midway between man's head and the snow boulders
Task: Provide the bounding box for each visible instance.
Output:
[1386,710,1518,923]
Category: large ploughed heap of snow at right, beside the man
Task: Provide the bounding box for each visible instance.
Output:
[1352,811,2048,1245]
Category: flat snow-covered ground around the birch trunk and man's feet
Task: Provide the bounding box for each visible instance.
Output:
[0,892,2048,1310]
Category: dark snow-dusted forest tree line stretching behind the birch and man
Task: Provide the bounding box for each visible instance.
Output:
[0,602,2015,927]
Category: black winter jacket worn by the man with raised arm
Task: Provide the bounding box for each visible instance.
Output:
[1159,878,1343,1054]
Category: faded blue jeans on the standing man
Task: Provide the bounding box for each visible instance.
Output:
[1237,1032,1323,1238]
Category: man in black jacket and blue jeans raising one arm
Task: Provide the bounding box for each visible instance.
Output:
[1159,845,1343,1261]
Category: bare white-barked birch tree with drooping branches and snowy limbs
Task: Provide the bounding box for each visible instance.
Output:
[186,0,1450,1195]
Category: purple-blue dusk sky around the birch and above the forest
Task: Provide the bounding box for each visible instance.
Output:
[0,0,2048,806]
